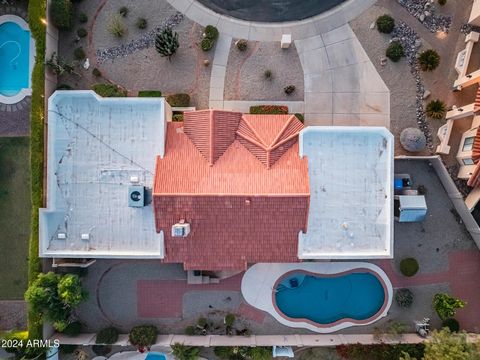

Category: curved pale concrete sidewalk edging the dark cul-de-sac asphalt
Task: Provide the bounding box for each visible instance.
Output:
[167,0,376,41]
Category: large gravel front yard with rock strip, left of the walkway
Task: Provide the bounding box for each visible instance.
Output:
[55,0,210,108]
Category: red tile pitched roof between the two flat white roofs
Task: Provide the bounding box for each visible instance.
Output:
[153,111,310,270]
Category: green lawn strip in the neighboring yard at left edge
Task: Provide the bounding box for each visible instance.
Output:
[0,137,31,300]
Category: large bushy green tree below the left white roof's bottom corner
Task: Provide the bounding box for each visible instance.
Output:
[25,272,87,331]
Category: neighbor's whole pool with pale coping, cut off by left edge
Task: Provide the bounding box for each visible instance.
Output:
[0,15,34,104]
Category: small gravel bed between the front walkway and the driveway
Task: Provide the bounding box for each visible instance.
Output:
[224,40,304,101]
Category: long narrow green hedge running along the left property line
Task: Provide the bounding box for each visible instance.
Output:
[28,0,47,340]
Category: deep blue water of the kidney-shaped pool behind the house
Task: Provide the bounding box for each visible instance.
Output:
[275,272,385,325]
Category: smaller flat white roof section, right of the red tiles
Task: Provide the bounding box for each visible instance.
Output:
[298,126,394,259]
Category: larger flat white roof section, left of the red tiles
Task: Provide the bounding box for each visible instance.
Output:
[40,91,167,258]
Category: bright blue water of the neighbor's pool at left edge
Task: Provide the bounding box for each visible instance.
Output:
[0,22,30,96]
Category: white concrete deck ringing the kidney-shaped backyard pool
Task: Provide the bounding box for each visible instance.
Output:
[241,262,393,333]
